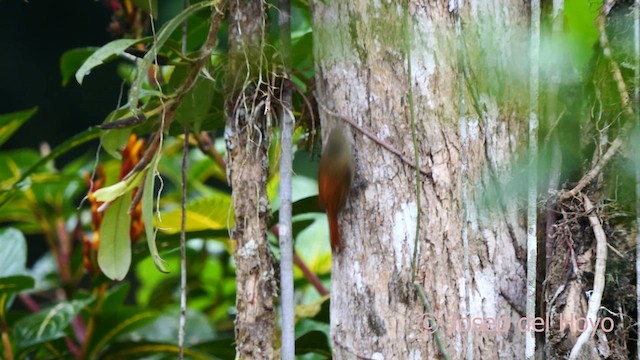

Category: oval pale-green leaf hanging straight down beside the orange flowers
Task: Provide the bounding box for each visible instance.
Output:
[98,193,131,280]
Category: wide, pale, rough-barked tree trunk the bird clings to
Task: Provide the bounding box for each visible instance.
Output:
[312,0,529,359]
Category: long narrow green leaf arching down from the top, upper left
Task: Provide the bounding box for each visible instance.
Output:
[129,1,214,109]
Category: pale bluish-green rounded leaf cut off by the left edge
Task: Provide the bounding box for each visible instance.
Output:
[0,228,27,277]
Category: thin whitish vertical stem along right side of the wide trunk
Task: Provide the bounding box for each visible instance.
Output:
[525,0,540,359]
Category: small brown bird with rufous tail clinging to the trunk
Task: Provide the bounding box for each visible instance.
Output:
[318,124,354,252]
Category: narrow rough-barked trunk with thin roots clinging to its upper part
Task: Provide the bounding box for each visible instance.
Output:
[225,1,277,359]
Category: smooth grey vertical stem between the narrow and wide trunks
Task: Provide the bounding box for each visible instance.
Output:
[278,0,295,360]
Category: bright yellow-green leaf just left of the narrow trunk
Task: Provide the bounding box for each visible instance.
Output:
[158,191,233,234]
